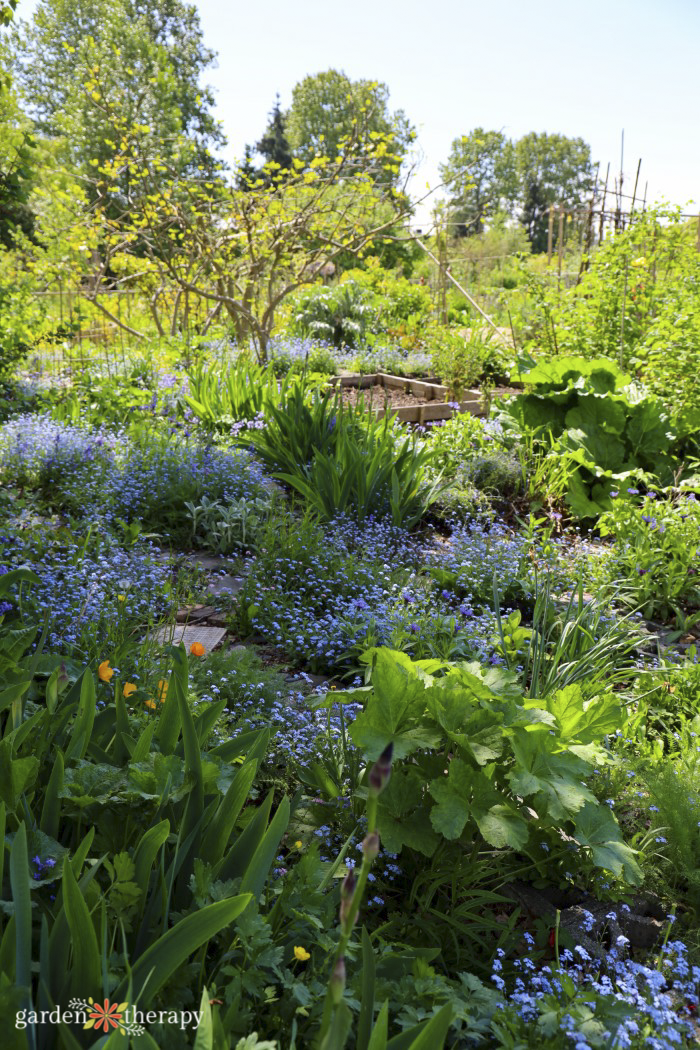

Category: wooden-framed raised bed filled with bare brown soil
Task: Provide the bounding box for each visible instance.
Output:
[331,372,487,423]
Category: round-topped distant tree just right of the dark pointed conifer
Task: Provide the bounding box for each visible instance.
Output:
[287,69,415,183]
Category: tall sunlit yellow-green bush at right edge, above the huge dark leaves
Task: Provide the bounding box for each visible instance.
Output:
[523,208,700,415]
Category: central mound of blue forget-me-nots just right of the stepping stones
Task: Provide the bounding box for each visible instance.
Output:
[246,518,517,670]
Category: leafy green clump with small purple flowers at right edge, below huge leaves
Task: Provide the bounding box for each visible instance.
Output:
[598,491,700,631]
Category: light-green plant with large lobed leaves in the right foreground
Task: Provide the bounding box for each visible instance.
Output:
[336,649,640,883]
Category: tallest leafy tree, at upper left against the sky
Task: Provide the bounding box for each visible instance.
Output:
[14,0,224,176]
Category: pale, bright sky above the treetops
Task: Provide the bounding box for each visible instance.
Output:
[19,0,700,221]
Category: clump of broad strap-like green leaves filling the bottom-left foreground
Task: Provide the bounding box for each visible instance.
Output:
[0,592,289,1024]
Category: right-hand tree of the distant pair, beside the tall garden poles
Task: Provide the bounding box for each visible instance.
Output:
[515,131,594,252]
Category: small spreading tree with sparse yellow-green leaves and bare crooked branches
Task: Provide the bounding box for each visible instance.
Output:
[52,67,409,360]
